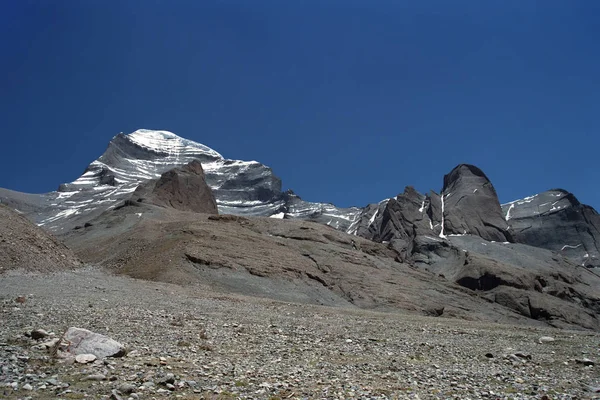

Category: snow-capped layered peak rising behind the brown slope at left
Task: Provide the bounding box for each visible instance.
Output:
[0,129,360,232]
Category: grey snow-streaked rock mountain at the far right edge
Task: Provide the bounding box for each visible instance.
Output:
[502,189,600,267]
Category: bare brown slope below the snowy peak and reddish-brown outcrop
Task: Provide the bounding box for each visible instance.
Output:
[58,205,547,326]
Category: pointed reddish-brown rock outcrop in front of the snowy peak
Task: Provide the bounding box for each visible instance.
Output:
[131,160,218,214]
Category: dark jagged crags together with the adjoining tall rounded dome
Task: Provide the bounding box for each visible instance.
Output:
[356,164,512,259]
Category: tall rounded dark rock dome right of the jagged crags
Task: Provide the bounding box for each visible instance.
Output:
[442,164,512,242]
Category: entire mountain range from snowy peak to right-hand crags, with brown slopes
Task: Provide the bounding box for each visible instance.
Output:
[0,130,600,330]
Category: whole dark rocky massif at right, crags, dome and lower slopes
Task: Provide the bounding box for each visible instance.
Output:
[342,165,600,329]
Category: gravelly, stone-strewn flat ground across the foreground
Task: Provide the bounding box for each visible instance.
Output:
[0,268,600,399]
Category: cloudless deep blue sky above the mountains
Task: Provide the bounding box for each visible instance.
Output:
[0,0,600,209]
